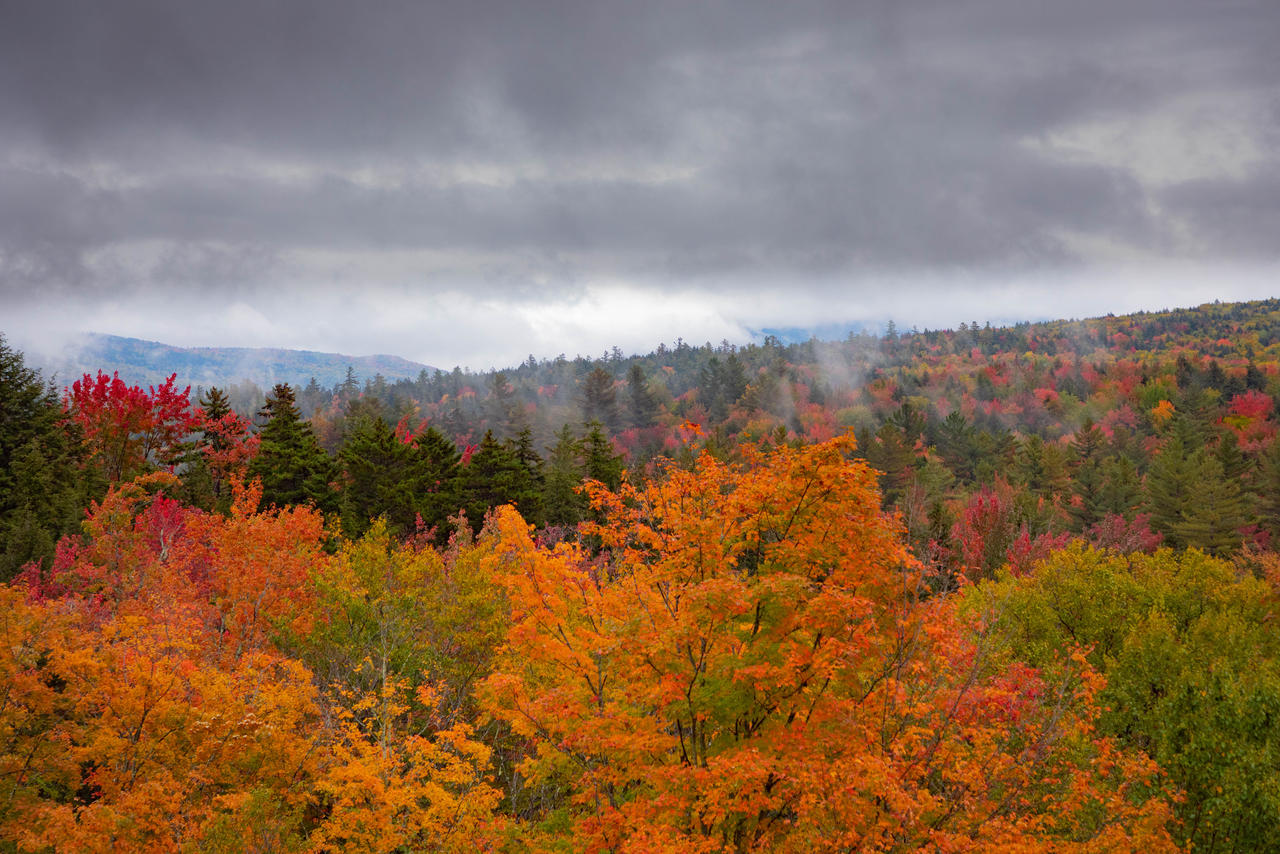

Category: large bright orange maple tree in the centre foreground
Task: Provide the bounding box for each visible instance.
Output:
[484,438,1170,851]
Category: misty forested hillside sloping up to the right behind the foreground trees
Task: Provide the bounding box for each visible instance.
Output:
[194,300,1280,572]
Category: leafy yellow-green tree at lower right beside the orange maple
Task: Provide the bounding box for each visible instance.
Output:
[968,545,1280,851]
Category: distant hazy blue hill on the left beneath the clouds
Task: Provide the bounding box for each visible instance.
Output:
[29,334,435,388]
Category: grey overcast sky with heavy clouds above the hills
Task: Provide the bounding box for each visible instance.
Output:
[0,0,1280,369]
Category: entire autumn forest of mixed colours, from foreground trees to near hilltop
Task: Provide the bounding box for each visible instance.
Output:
[0,301,1280,851]
